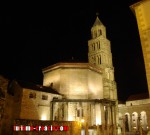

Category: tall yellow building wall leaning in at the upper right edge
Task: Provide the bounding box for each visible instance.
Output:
[131,0,150,95]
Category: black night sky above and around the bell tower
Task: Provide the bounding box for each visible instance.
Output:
[0,0,147,100]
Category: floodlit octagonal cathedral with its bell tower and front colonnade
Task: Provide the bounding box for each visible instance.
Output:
[43,17,117,133]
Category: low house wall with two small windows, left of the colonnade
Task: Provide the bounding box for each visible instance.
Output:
[20,89,61,120]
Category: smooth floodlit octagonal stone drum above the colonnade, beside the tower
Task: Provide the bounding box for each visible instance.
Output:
[43,63,103,99]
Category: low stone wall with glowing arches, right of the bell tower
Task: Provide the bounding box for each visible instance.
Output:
[118,99,150,131]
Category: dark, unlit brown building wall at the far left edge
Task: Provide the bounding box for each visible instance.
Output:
[1,79,22,134]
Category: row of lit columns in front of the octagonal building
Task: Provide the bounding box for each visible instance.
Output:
[51,99,117,132]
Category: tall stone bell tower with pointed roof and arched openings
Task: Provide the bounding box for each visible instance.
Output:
[88,16,117,99]
